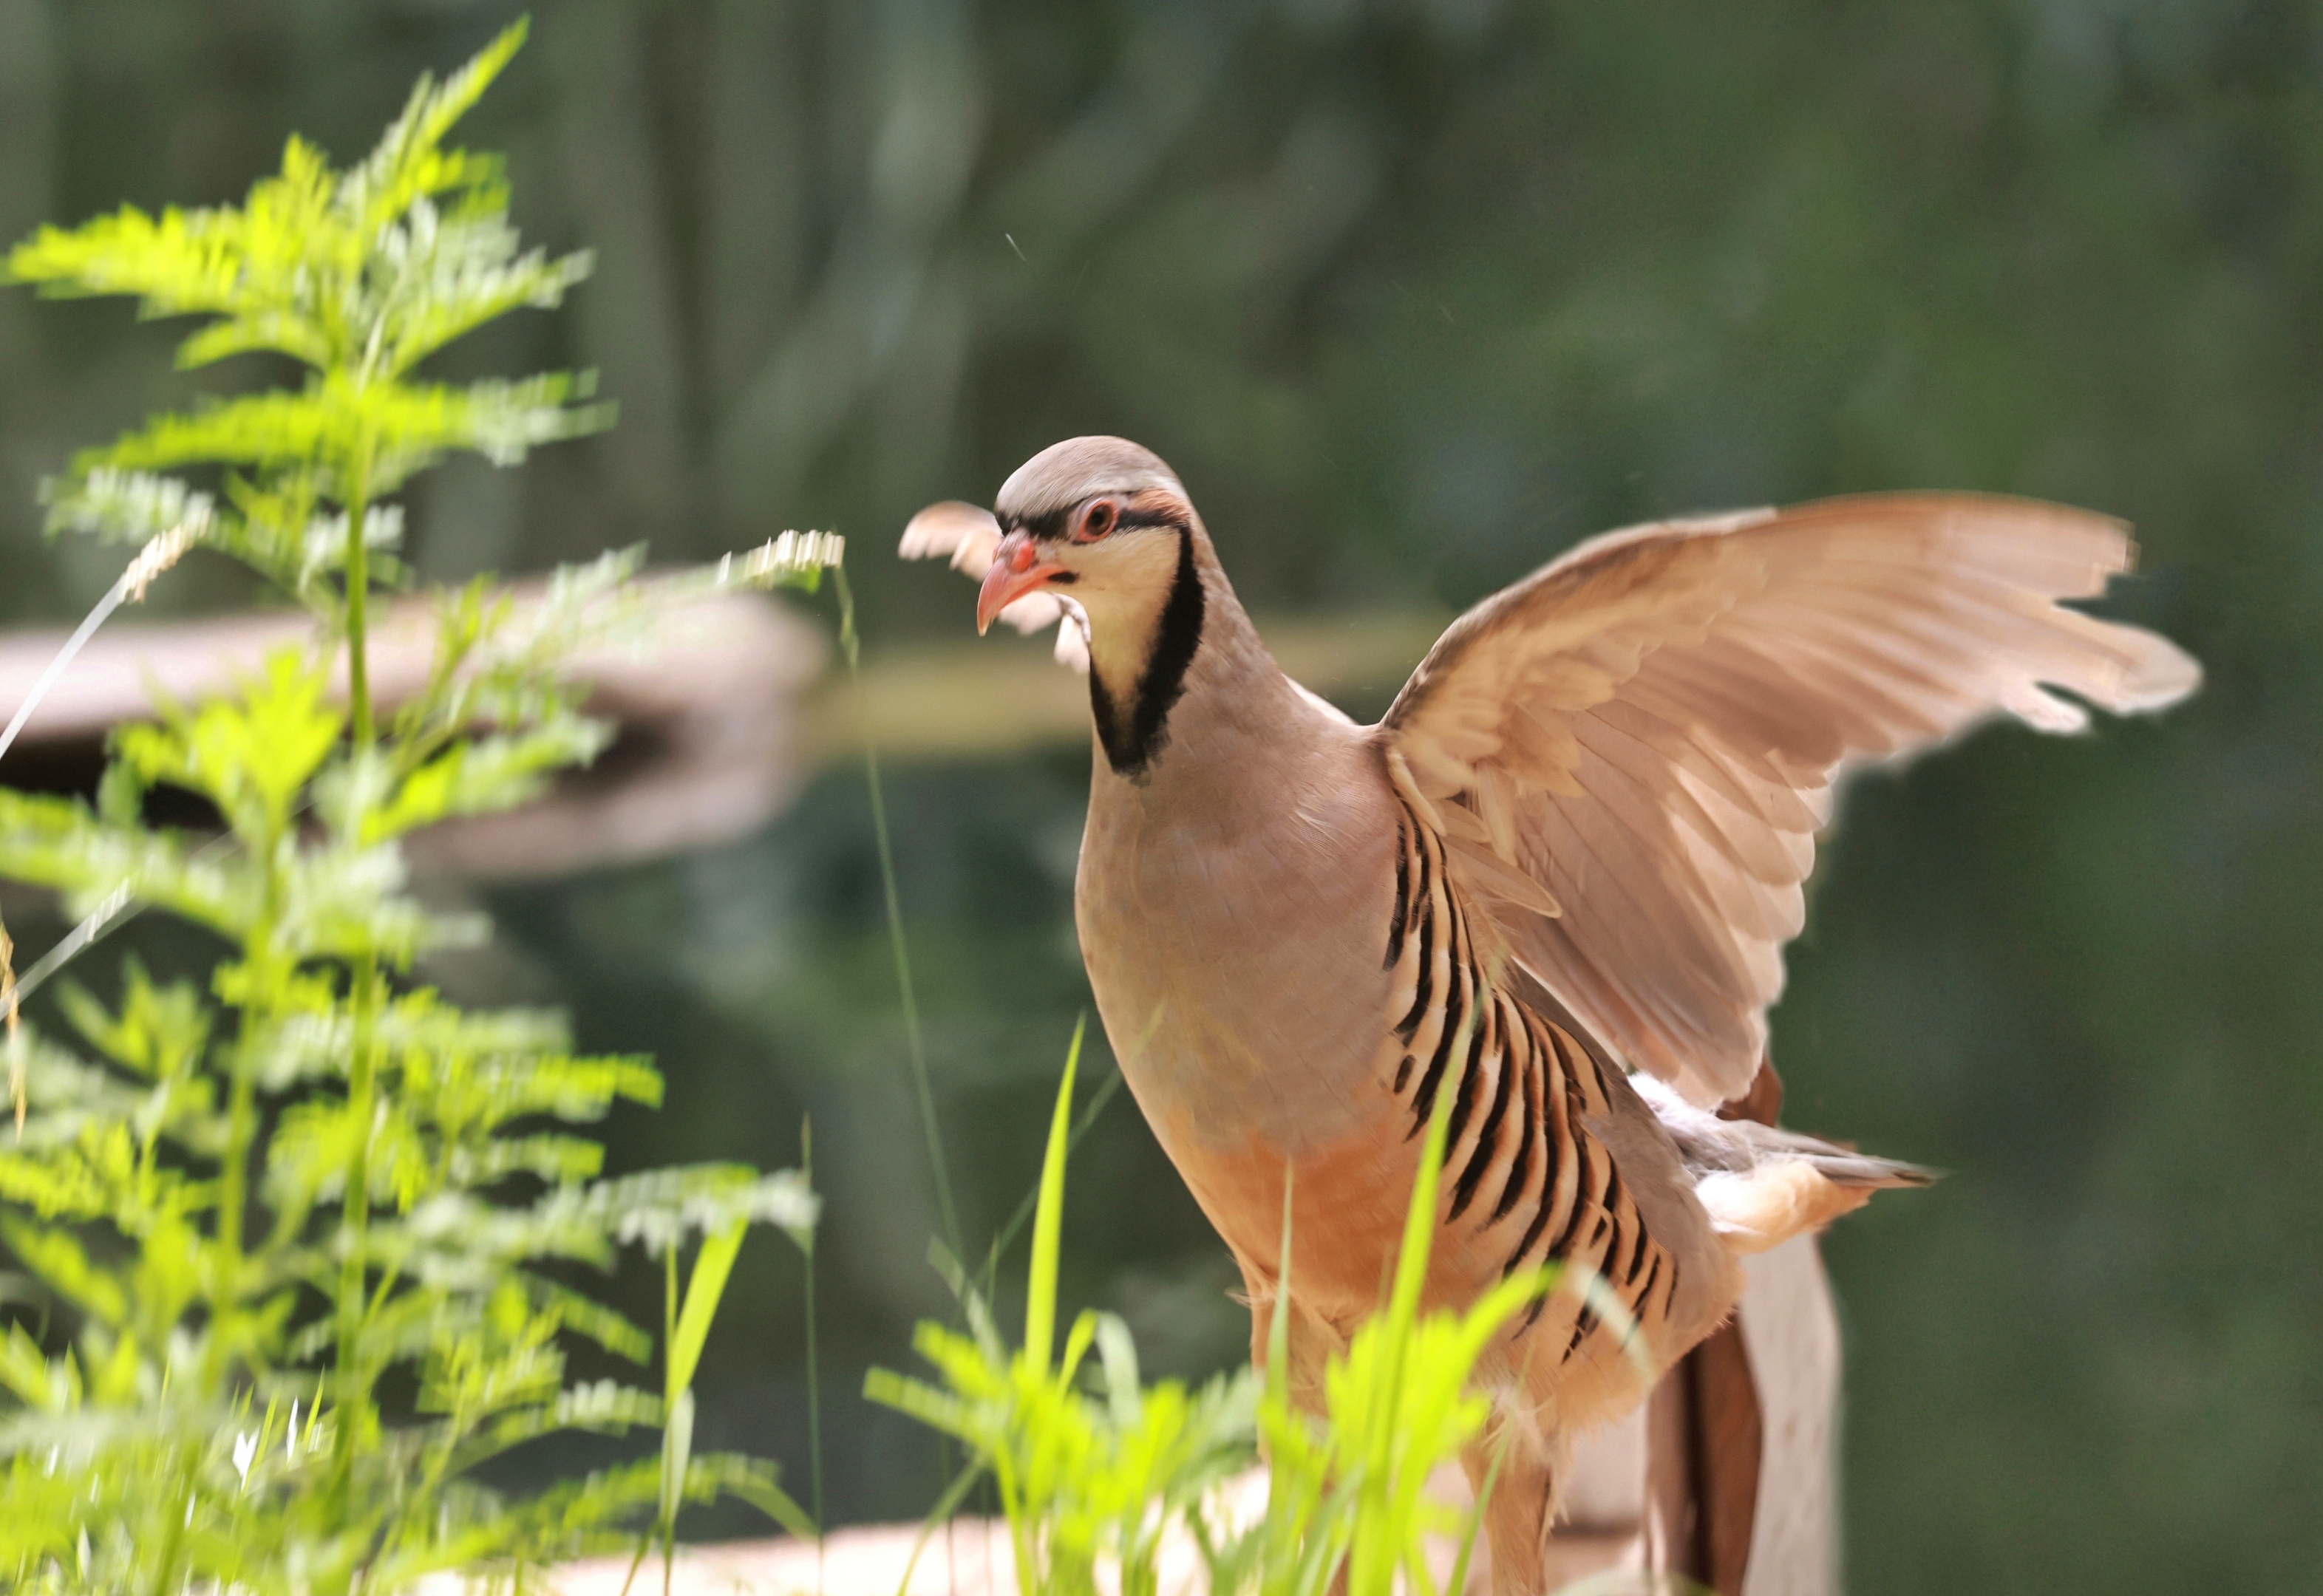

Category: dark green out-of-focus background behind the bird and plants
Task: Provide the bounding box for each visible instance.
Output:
[0,0,2323,1596]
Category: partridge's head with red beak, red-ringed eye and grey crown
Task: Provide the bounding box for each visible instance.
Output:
[976,437,1197,648]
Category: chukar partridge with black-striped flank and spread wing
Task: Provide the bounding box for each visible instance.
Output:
[904,437,2200,1594]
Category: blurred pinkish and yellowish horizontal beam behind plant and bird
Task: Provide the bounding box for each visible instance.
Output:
[0,597,1443,878]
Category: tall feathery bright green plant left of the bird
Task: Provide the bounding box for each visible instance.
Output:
[0,26,839,1596]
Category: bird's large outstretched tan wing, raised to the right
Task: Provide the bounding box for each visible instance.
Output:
[1380,495,2200,1103]
